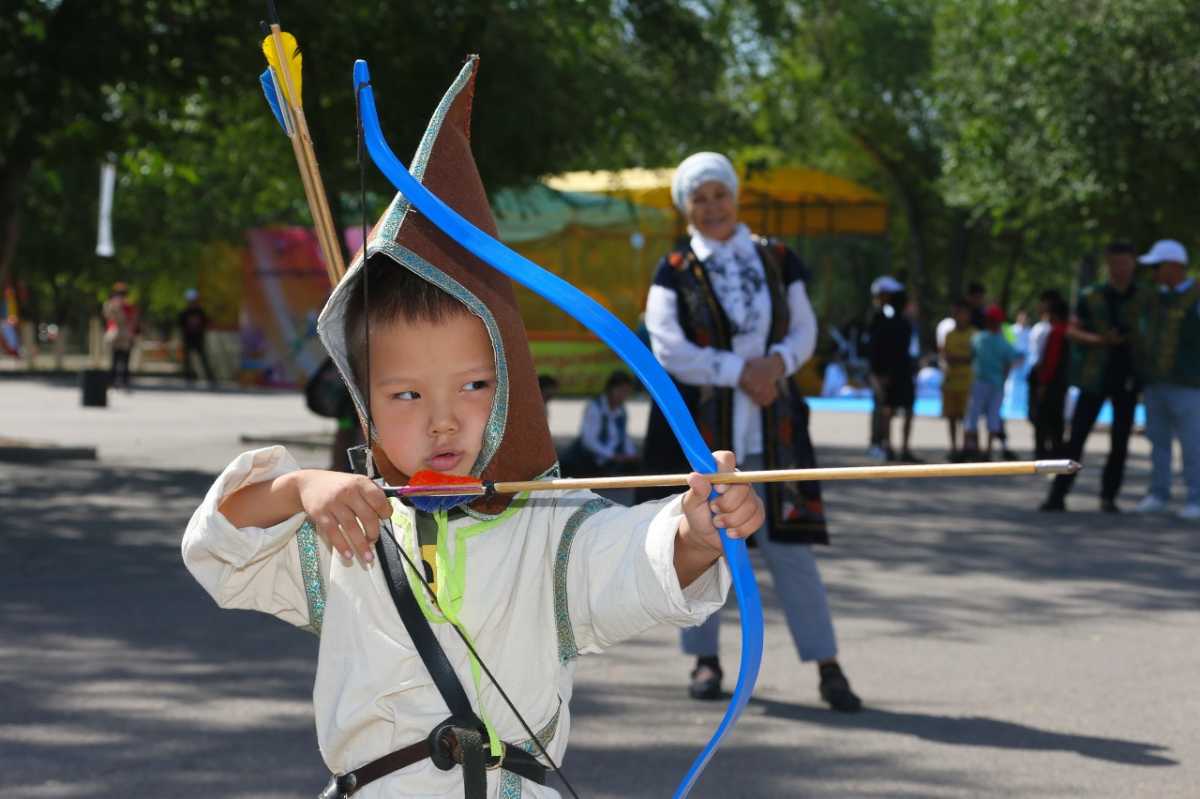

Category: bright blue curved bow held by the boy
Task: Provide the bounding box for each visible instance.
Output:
[354,59,763,799]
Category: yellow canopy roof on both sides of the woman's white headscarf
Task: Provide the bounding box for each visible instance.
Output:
[545,167,888,238]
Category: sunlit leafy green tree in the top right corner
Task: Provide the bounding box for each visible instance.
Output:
[935,0,1200,270]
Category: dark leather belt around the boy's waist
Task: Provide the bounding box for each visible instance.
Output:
[318,717,546,799]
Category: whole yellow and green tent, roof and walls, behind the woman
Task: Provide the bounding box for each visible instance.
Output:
[492,167,888,394]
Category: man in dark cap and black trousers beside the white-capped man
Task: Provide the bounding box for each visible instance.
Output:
[1042,241,1148,513]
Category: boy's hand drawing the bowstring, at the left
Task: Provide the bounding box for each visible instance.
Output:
[292,469,391,563]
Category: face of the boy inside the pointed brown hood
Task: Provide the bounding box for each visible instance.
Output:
[371,312,496,475]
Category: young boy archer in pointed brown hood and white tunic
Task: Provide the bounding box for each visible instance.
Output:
[182,59,763,799]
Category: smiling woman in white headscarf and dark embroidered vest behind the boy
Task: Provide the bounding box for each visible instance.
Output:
[638,152,862,711]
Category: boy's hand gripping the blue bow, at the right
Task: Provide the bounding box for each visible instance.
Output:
[677,450,766,556]
